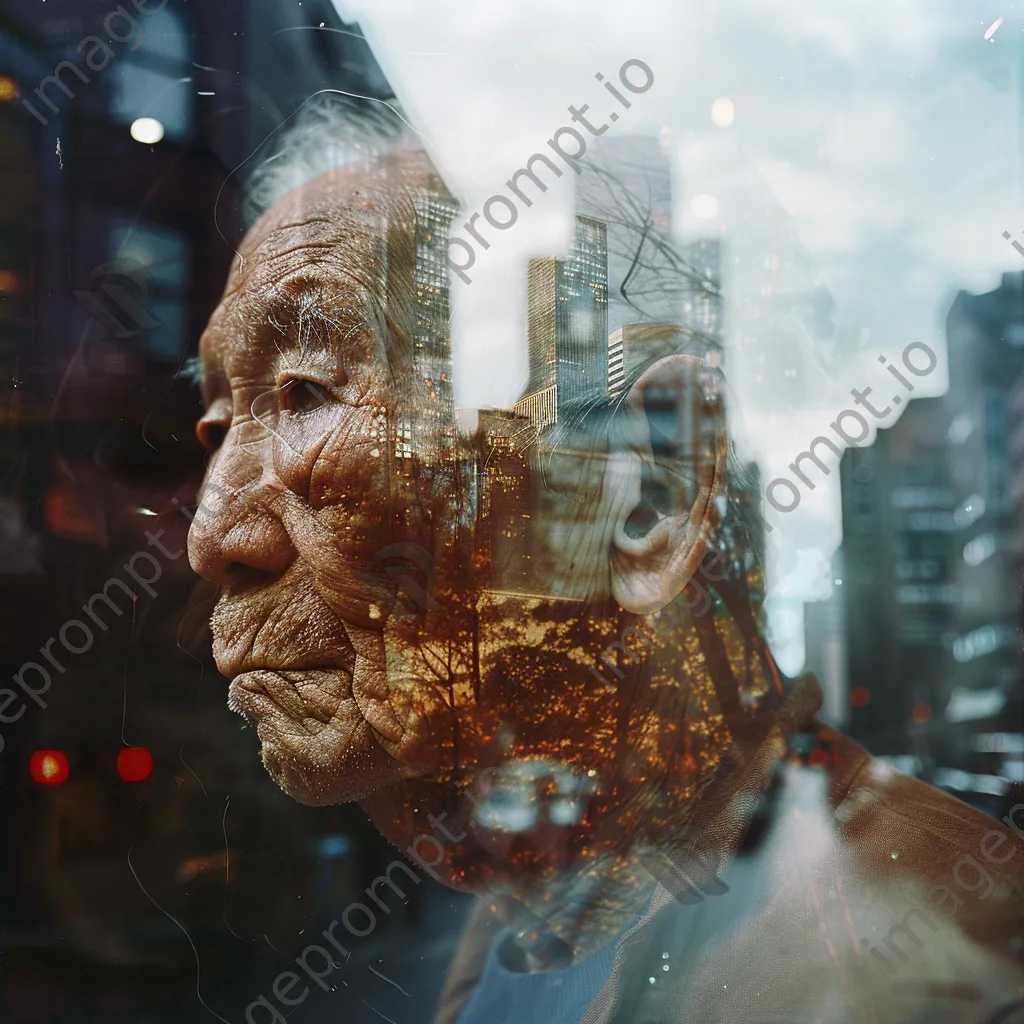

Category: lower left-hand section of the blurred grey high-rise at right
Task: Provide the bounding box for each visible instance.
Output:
[840,398,958,755]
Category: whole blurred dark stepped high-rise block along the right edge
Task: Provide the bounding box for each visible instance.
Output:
[841,272,1024,769]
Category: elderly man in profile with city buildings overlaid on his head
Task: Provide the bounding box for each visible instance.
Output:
[189,103,1024,1024]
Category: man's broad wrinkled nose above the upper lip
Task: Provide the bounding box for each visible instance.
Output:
[188,469,296,587]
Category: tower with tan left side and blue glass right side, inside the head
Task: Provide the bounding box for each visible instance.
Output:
[516,217,608,418]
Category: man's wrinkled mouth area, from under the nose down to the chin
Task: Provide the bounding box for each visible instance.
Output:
[212,585,449,805]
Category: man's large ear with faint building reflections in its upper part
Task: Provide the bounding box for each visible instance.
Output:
[607,355,727,614]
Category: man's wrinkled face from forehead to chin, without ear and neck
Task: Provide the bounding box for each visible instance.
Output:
[189,167,464,804]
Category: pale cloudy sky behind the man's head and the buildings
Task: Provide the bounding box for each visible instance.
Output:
[335,0,1024,671]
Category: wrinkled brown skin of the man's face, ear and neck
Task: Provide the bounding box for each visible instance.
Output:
[189,154,770,955]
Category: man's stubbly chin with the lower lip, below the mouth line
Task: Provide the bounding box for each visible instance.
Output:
[228,669,422,807]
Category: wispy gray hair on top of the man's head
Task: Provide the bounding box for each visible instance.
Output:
[245,90,415,224]
